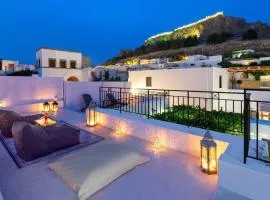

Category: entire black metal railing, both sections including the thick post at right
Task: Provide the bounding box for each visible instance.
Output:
[100,87,270,163]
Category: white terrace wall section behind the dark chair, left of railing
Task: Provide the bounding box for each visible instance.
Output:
[65,82,130,111]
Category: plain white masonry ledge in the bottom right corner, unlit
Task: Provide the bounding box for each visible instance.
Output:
[218,153,270,200]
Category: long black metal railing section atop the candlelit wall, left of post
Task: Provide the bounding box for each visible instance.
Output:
[100,87,244,135]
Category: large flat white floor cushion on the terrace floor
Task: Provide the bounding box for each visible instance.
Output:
[49,141,149,200]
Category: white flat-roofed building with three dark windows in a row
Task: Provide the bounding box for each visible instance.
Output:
[36,48,91,81]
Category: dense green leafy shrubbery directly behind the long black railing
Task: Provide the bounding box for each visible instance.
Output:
[153,105,243,136]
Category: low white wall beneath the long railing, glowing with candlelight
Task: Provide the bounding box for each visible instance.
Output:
[99,110,234,159]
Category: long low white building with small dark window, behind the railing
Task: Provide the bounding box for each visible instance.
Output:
[128,67,229,91]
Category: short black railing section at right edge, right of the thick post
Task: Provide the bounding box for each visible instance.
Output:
[244,89,270,163]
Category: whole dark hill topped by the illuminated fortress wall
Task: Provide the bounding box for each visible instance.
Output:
[106,12,270,64]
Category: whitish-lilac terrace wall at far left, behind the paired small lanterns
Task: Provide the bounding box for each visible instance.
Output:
[0,76,63,112]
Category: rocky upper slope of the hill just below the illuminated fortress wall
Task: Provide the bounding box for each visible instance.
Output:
[145,12,270,44]
